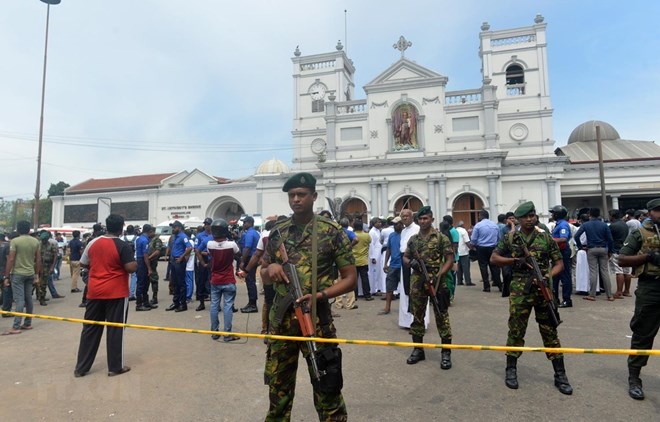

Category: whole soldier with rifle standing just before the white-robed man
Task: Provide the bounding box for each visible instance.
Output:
[403,206,454,369]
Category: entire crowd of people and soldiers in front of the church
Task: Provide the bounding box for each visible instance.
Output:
[0,188,660,420]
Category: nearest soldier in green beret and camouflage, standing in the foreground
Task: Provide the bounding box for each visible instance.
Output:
[261,173,357,421]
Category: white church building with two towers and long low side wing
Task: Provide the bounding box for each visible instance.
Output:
[52,15,660,231]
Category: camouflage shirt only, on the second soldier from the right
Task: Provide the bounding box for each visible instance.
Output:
[495,228,562,275]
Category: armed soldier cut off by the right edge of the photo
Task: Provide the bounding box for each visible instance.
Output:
[619,198,660,400]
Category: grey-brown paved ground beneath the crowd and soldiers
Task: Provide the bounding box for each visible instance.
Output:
[0,263,660,421]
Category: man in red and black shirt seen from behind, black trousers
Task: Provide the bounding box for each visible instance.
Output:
[73,214,137,377]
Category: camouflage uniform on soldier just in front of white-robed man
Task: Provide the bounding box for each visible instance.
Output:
[406,231,454,343]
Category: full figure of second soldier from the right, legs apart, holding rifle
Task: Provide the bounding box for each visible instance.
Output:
[491,201,573,395]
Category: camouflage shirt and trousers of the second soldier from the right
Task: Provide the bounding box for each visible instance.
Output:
[495,228,564,360]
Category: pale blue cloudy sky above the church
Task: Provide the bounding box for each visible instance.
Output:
[0,0,660,200]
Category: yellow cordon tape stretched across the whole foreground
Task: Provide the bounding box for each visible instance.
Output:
[0,311,660,356]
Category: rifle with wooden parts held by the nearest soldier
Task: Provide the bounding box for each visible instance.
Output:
[280,244,326,382]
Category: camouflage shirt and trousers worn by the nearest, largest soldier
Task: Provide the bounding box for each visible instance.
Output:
[264,218,355,421]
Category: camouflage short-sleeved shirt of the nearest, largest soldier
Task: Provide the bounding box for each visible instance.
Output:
[264,218,354,296]
